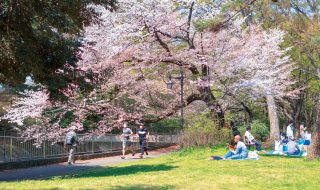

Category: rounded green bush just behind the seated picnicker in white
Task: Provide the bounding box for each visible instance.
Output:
[238,120,269,141]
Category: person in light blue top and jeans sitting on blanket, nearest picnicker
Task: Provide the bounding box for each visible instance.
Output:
[223,135,248,160]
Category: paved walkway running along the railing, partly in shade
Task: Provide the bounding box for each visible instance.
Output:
[0,147,177,182]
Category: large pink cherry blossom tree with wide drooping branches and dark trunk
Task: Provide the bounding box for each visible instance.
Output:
[1,0,294,138]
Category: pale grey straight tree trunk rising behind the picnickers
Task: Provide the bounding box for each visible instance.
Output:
[267,95,280,140]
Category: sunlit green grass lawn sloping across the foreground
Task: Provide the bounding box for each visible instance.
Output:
[0,148,320,190]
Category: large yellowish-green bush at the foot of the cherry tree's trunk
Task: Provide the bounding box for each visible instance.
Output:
[179,114,232,147]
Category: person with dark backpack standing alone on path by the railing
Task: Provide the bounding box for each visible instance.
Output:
[64,126,78,165]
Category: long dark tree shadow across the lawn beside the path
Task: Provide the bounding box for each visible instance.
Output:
[63,164,177,178]
